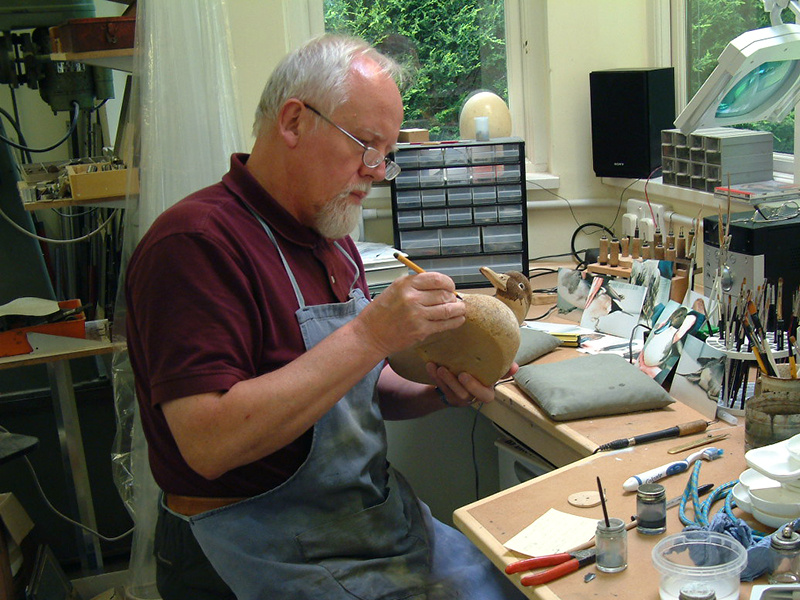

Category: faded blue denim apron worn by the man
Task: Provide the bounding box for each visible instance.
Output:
[178,215,519,600]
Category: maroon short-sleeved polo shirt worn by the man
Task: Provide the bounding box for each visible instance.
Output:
[125,154,367,497]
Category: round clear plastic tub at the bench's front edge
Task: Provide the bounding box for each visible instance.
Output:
[652,530,747,600]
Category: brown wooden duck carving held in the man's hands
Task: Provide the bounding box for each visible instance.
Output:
[389,267,533,386]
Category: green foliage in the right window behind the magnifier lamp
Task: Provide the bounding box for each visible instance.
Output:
[687,0,795,154]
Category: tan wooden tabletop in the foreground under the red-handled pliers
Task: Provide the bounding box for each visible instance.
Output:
[453,424,772,600]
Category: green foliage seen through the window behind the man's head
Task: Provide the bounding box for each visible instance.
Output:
[325,0,508,140]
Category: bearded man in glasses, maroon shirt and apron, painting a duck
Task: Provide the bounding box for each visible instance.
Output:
[126,36,518,600]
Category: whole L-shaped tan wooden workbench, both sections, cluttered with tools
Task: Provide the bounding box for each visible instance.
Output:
[453,264,771,600]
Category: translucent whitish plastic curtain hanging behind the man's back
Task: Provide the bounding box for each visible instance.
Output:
[112,0,245,598]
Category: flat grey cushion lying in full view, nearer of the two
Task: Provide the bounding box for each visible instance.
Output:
[514,354,675,421]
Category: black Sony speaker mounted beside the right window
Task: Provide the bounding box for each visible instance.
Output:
[589,67,675,179]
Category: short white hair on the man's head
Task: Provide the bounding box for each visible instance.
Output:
[253,34,402,137]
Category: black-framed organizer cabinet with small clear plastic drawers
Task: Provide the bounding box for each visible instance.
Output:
[392,138,528,287]
